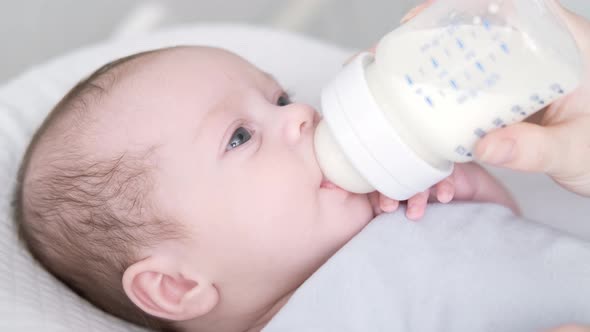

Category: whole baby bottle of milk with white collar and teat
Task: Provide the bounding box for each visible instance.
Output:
[315,0,583,200]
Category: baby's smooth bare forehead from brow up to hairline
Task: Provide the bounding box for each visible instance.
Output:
[85,47,280,152]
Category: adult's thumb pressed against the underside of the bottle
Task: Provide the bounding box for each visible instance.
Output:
[475,122,564,173]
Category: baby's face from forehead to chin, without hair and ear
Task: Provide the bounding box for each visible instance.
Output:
[104,48,372,312]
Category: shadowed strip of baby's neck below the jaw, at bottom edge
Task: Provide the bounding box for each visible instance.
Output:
[176,290,295,332]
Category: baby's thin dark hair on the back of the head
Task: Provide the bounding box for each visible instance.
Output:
[13,50,183,331]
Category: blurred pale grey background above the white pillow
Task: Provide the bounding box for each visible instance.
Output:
[0,0,590,82]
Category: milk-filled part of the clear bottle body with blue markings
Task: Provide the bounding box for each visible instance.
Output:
[366,25,580,164]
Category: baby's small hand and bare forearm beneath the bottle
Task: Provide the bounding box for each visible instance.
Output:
[369,163,519,220]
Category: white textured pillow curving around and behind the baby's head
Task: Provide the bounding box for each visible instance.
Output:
[0,25,590,332]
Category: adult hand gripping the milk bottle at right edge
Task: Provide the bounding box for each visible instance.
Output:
[475,1,590,197]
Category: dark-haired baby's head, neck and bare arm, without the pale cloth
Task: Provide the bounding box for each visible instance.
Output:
[15,47,516,332]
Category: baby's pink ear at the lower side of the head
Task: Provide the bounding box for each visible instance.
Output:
[123,256,219,321]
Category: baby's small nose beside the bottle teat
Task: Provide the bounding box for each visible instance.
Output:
[284,104,319,144]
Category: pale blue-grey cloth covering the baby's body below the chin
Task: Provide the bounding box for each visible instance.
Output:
[264,204,590,332]
